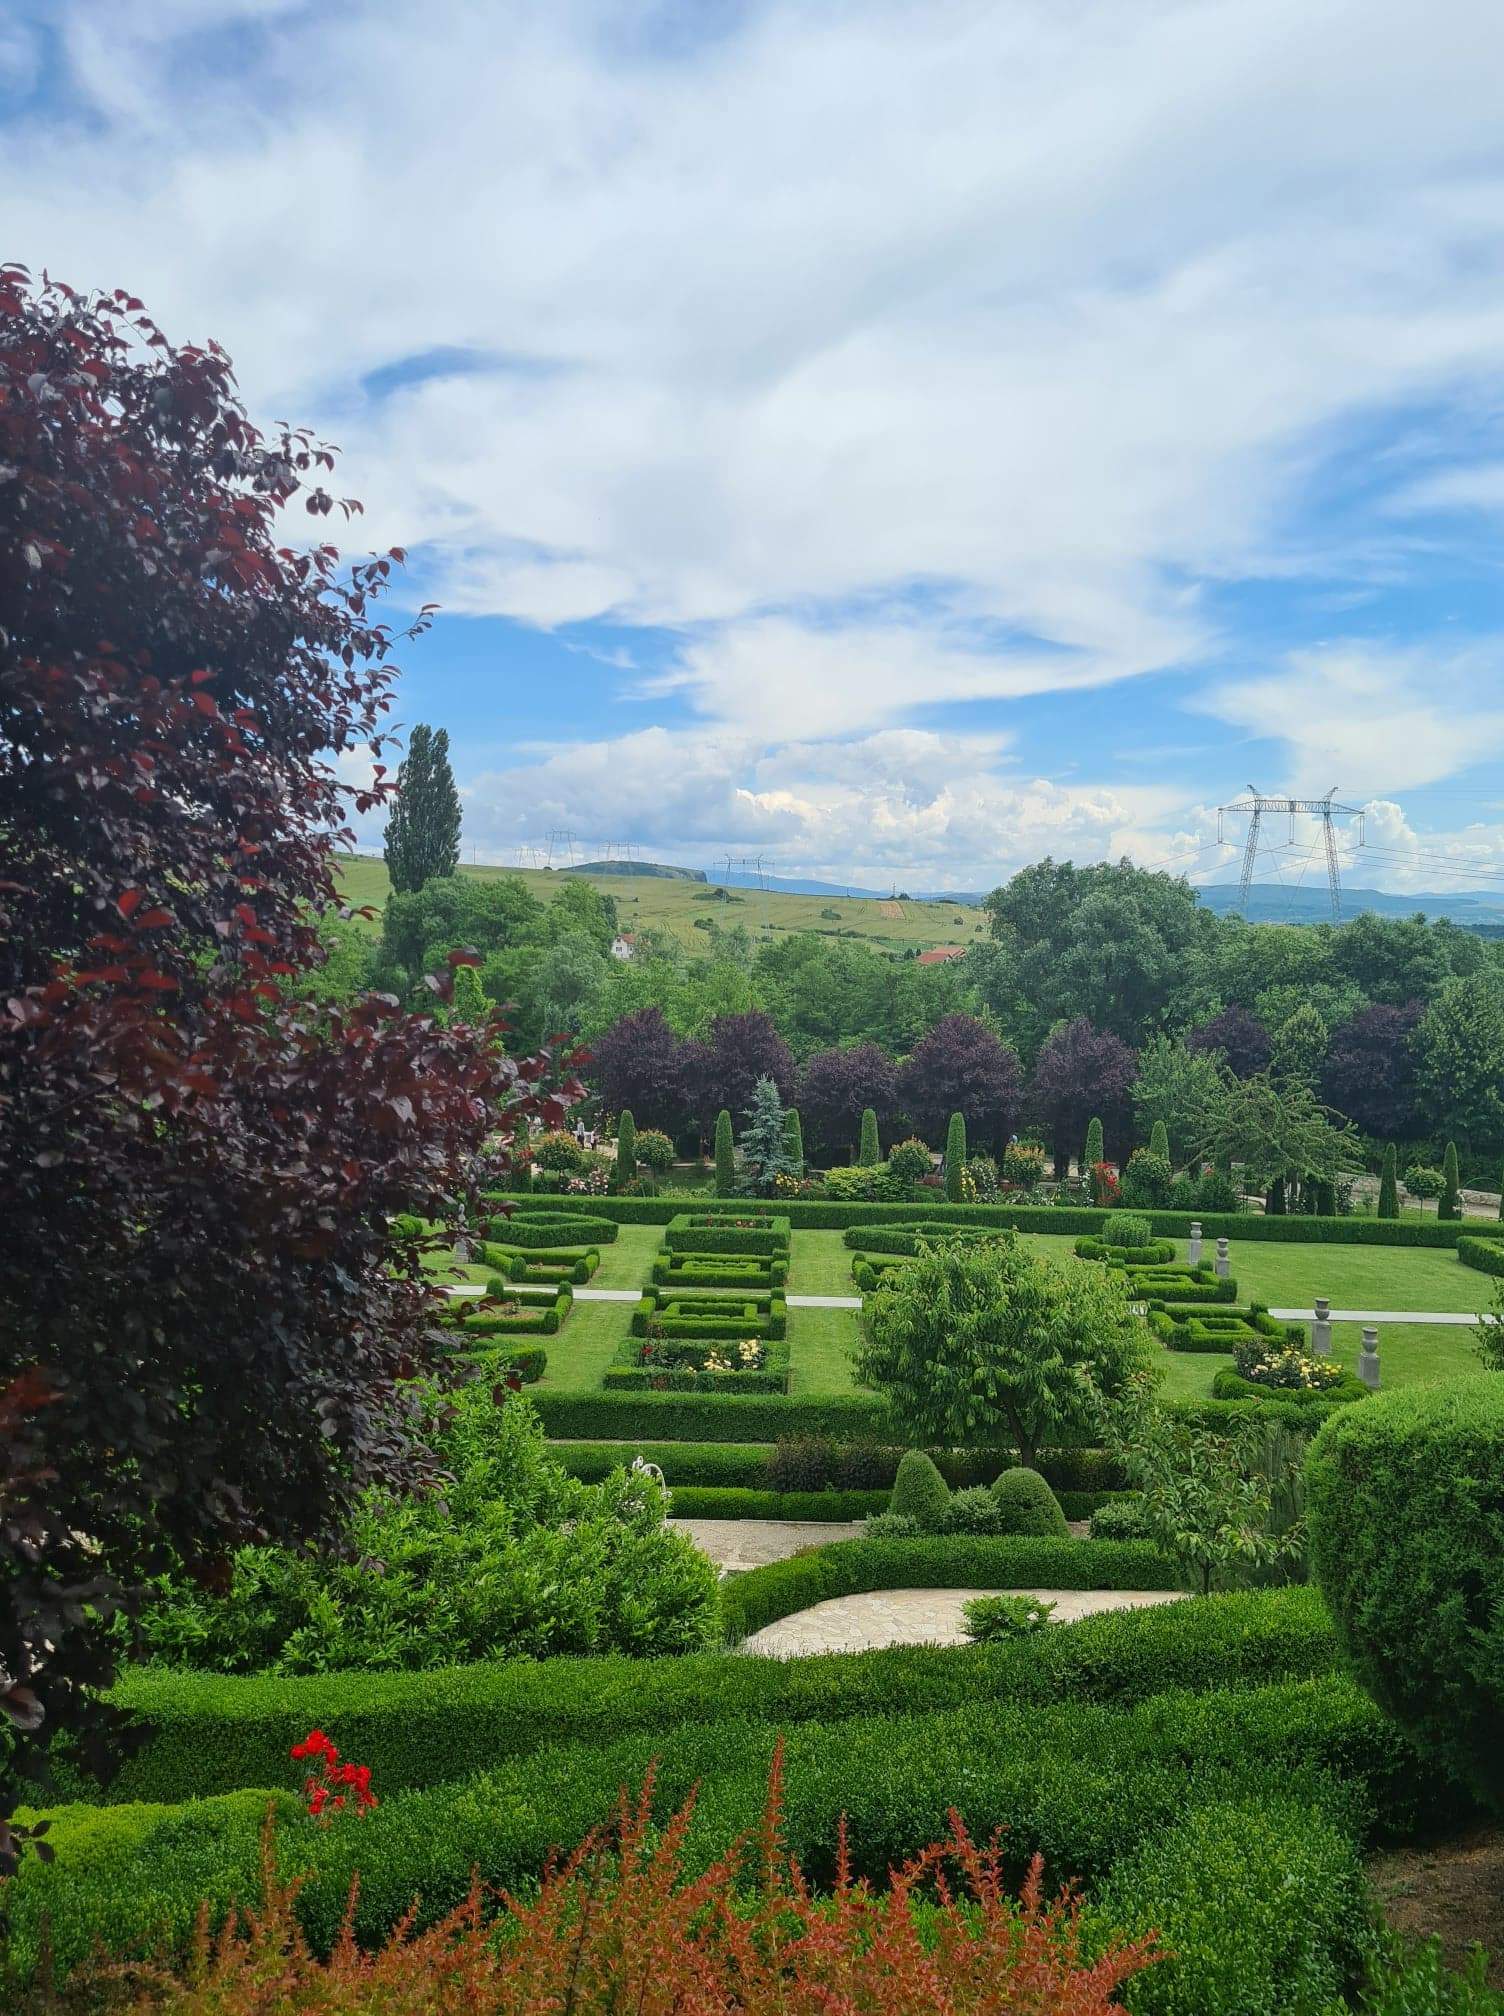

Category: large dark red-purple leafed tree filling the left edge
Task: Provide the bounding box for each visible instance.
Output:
[0,268,569,1869]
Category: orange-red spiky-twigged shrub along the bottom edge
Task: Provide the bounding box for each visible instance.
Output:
[99,1754,1159,2016]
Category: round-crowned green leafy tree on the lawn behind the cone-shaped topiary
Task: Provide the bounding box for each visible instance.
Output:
[857,1232,1149,1470]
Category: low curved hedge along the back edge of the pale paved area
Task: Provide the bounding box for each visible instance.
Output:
[722,1534,1179,1645]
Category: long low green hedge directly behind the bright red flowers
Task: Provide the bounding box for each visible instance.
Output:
[64,1589,1339,1804]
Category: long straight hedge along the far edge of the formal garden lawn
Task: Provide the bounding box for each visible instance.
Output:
[490,1191,1466,1246]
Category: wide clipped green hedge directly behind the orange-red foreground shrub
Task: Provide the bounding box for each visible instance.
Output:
[20,1647,1456,1983]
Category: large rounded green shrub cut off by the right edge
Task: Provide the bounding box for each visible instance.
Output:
[1306,1373,1504,1810]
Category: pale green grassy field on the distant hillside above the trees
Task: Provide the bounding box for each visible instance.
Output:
[341,855,986,954]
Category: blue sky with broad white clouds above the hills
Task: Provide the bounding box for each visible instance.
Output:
[0,0,1504,889]
